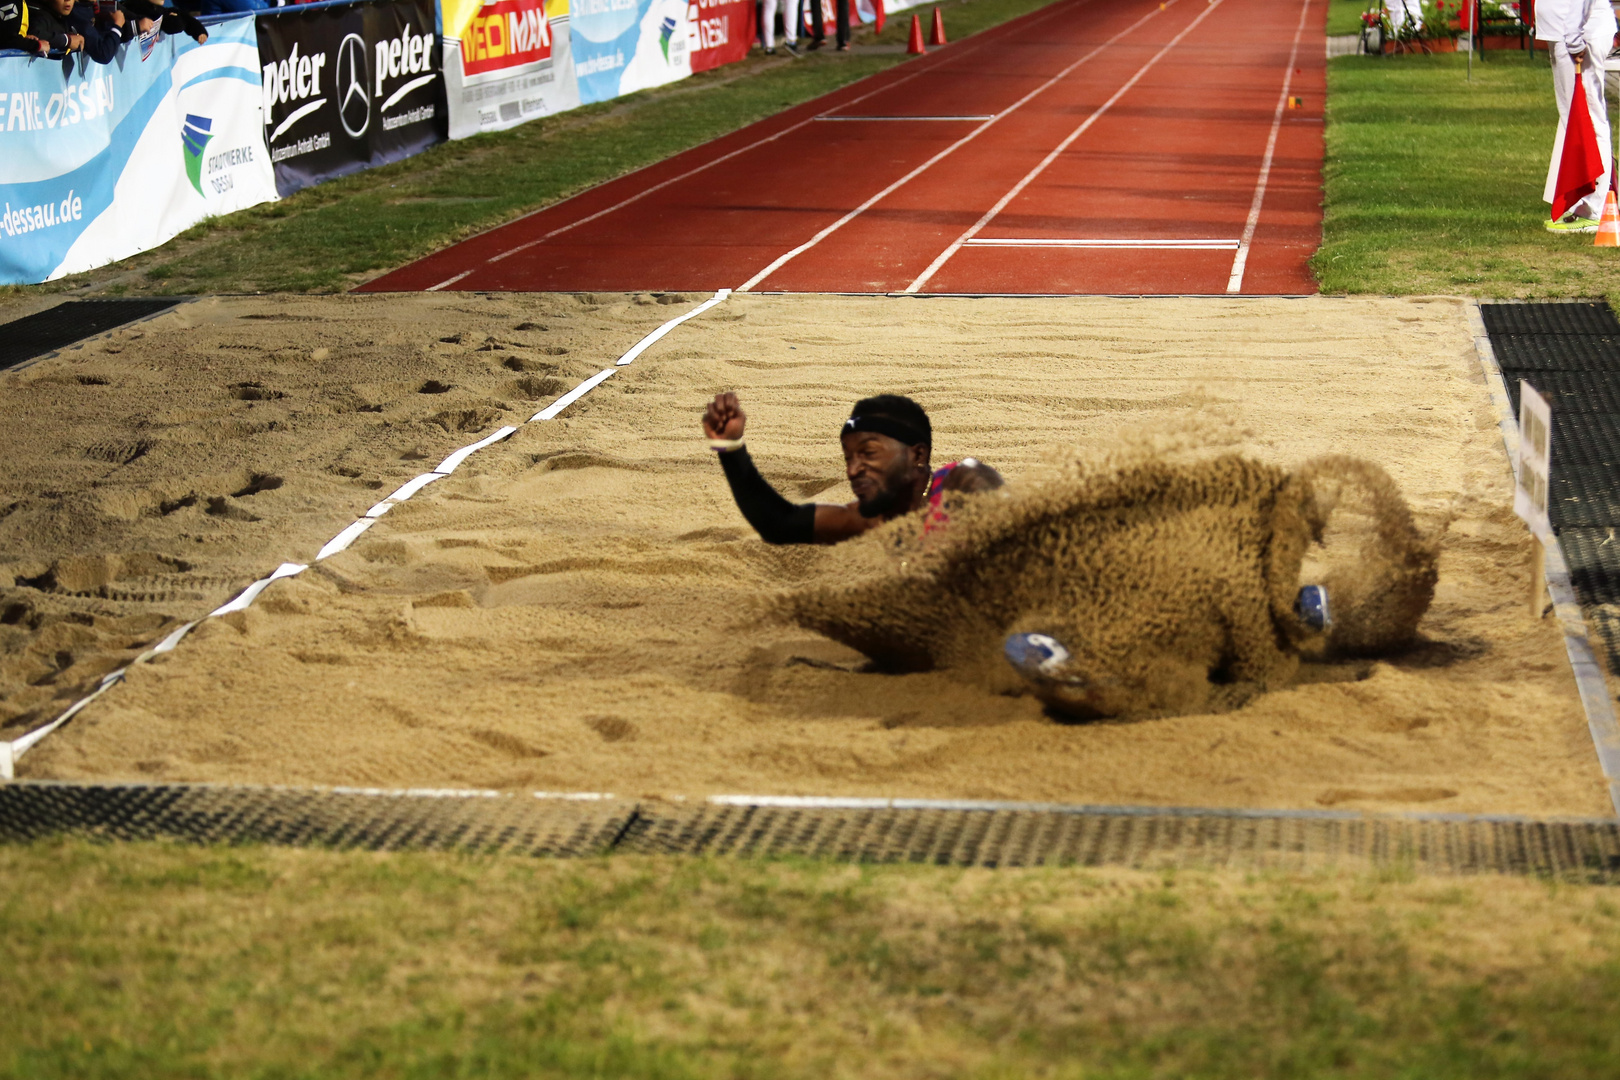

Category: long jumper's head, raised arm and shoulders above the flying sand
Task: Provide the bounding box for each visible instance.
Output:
[703,393,1001,544]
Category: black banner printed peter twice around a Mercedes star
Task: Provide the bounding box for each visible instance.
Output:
[258,0,446,196]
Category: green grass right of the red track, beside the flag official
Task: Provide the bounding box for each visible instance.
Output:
[1314,52,1620,298]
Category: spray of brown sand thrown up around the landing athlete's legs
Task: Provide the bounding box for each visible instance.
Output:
[778,450,1439,717]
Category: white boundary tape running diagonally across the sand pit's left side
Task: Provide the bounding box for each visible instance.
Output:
[0,288,731,777]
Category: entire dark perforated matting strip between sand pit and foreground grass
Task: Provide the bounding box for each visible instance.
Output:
[0,782,1620,882]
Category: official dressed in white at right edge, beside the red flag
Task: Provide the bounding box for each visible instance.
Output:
[1536,0,1615,233]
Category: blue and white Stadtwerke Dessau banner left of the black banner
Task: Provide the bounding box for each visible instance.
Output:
[0,18,275,283]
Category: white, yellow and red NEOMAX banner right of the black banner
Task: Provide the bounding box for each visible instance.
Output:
[444,0,580,139]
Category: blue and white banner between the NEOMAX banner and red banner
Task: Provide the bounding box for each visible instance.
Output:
[570,0,697,105]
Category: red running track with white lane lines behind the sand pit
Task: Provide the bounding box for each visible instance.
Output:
[361,0,1327,295]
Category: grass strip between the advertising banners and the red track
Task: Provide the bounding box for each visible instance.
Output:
[8,0,1050,295]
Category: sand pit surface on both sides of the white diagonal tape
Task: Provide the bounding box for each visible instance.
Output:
[0,296,1609,814]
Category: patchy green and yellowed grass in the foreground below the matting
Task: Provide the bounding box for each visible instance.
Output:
[9,842,1620,1080]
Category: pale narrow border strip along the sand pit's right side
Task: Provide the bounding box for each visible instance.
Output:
[1466,300,1620,814]
